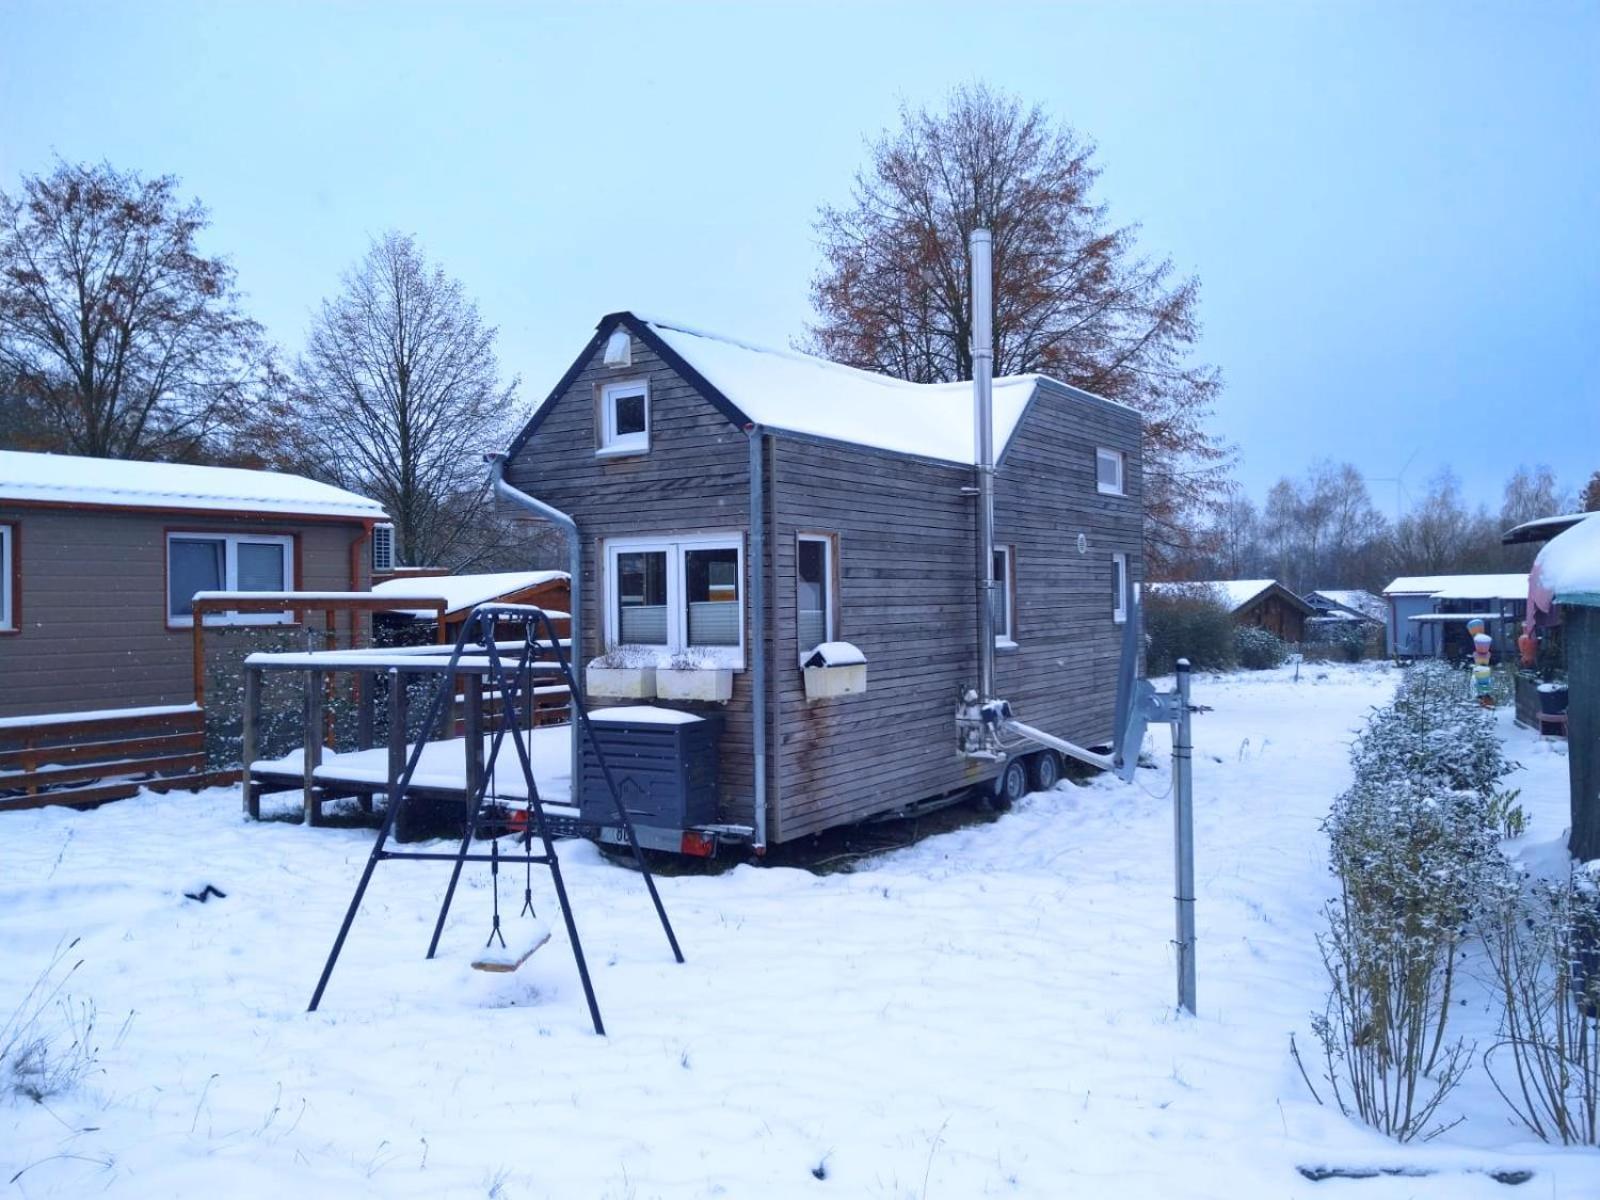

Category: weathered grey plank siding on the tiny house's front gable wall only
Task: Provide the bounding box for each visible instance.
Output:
[506,338,755,824]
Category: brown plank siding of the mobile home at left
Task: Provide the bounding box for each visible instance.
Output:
[0,504,370,717]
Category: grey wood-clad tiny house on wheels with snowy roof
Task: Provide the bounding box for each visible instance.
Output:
[496,312,1144,848]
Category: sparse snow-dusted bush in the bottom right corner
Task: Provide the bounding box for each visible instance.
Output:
[1482,862,1600,1146]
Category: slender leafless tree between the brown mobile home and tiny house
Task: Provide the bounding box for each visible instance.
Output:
[298,232,517,570]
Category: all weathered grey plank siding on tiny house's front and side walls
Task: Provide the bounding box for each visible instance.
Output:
[506,324,1142,843]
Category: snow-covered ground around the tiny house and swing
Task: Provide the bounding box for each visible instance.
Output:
[0,667,1600,1200]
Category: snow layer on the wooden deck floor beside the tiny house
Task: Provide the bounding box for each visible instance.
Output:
[251,714,576,805]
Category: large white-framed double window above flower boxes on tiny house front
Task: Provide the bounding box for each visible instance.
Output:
[606,536,744,667]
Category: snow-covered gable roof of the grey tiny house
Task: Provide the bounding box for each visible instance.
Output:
[510,312,1134,466]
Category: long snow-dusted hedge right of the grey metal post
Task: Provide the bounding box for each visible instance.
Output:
[1312,664,1510,1141]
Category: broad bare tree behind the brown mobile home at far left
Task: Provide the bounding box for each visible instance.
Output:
[0,163,259,458]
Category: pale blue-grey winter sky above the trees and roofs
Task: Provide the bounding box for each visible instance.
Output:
[0,0,1600,509]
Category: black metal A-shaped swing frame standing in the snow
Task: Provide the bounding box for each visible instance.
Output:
[306,603,683,1035]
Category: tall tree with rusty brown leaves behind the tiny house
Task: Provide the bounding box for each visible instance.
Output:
[808,85,1232,571]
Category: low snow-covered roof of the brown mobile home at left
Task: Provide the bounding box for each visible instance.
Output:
[0,450,384,520]
